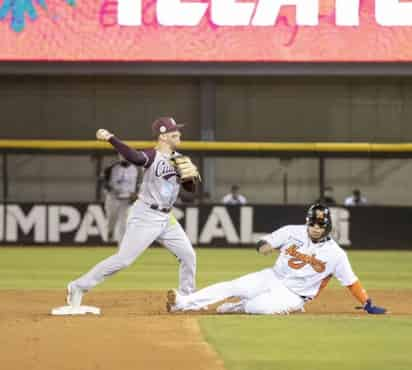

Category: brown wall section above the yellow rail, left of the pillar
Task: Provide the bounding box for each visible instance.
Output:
[0,77,199,140]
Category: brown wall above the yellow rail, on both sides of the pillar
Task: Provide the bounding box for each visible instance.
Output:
[0,76,412,142]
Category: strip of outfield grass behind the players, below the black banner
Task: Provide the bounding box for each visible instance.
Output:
[0,248,412,290]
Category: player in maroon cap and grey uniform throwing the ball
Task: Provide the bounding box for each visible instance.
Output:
[67,117,200,308]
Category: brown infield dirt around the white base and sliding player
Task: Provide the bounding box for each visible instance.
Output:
[0,289,412,370]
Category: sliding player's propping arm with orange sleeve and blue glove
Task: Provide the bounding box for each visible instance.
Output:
[334,252,386,315]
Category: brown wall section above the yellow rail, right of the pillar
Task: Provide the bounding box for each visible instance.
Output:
[217,78,412,142]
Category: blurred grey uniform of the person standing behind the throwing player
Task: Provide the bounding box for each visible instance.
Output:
[104,160,140,243]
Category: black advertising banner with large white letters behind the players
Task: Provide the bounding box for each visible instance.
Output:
[0,203,412,249]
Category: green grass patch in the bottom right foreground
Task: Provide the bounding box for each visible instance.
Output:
[200,315,412,370]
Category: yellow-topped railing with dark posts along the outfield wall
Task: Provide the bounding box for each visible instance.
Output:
[0,139,412,204]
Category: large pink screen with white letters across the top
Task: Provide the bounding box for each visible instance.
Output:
[0,0,412,62]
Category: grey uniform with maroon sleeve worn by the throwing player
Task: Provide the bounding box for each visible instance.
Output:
[72,137,196,294]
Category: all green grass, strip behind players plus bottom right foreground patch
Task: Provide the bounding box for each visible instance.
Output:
[0,248,412,370]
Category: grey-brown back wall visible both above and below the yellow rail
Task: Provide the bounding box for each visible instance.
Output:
[0,77,412,205]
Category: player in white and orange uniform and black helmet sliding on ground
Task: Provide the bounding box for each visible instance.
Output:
[167,204,386,314]
